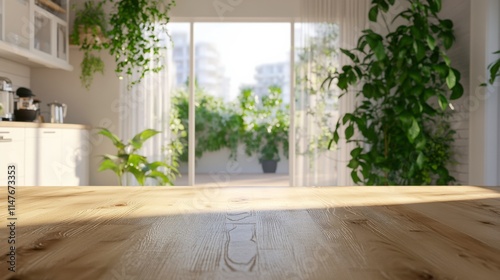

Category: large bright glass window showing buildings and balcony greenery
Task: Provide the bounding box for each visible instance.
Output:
[169,22,291,186]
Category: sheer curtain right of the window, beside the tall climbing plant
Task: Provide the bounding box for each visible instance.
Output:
[291,0,369,186]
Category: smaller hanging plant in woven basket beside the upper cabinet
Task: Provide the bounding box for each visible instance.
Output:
[70,1,107,90]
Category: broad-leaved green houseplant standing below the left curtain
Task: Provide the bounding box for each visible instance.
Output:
[99,128,178,186]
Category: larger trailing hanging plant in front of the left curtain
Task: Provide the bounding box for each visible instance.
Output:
[103,0,175,86]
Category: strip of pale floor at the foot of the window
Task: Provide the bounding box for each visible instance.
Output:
[175,173,289,187]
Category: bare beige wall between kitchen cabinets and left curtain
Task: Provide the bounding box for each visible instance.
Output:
[31,47,120,185]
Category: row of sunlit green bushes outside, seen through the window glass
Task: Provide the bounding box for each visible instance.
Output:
[172,86,290,162]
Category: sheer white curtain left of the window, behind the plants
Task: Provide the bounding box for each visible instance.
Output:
[120,48,175,185]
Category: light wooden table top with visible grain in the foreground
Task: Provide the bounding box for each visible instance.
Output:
[0,186,500,280]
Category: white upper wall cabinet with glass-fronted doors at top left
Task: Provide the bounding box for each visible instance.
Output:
[0,0,73,70]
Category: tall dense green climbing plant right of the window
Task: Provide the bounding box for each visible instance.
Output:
[325,0,464,185]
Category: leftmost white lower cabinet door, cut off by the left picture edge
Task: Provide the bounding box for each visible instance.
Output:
[0,127,25,186]
